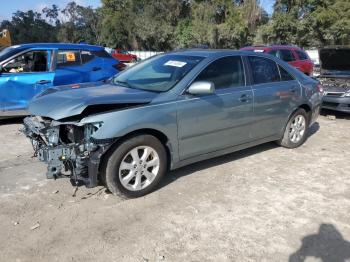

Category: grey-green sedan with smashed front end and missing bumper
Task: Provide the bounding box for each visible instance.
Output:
[24,50,322,197]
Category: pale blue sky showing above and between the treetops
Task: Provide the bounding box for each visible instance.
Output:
[0,0,275,21]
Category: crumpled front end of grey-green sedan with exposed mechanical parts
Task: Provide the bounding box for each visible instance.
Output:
[22,116,113,187]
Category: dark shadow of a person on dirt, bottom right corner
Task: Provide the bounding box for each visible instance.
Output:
[289,224,350,262]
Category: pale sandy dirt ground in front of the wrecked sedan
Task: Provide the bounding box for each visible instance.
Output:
[0,113,350,262]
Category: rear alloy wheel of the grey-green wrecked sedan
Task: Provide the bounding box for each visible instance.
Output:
[277,108,309,148]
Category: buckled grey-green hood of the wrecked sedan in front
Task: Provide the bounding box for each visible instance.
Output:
[29,82,158,120]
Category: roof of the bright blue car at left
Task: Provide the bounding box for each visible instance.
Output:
[12,43,104,51]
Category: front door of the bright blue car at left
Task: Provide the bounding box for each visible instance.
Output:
[0,48,54,115]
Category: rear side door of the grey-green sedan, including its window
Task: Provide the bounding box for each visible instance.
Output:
[247,56,301,139]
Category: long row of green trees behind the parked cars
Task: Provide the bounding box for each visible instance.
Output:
[0,0,350,51]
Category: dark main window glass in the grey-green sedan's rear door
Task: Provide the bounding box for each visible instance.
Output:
[248,56,280,84]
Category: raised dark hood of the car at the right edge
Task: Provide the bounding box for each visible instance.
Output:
[319,47,350,75]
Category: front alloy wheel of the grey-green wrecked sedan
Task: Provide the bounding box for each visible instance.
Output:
[104,135,167,197]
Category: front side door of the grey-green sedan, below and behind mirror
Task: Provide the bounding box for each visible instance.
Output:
[177,56,253,160]
